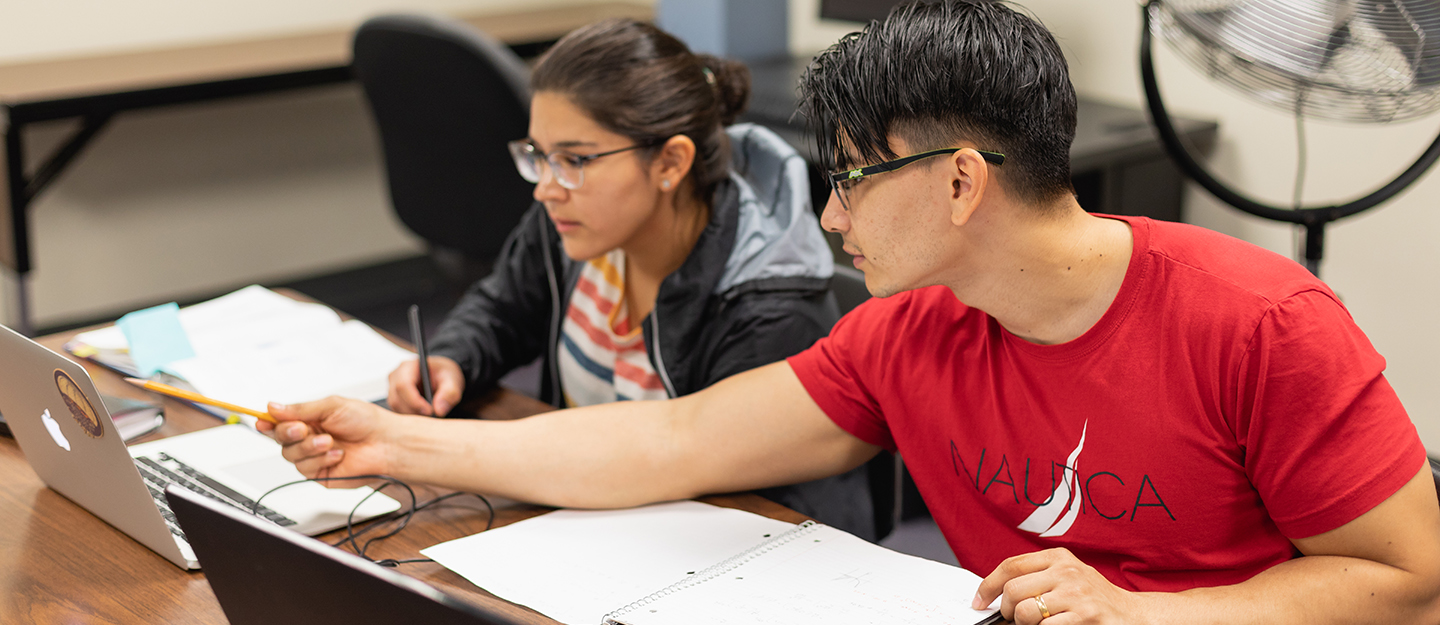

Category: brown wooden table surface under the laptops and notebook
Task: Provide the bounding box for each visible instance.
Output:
[0,324,805,625]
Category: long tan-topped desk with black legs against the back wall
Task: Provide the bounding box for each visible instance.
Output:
[0,1,654,334]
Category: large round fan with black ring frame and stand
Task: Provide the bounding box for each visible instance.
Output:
[1140,0,1440,275]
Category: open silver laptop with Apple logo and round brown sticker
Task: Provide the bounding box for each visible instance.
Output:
[0,325,400,569]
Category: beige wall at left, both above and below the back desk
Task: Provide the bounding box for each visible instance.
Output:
[0,0,642,327]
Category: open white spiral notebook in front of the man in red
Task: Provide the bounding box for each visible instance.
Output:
[423,501,998,625]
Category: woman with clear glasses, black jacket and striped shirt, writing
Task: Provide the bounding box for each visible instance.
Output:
[389,20,874,539]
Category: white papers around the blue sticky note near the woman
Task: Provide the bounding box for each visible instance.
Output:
[66,287,415,410]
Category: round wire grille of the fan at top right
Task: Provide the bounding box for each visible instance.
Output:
[1155,0,1440,122]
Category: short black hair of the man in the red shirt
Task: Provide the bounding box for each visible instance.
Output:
[801,0,1076,203]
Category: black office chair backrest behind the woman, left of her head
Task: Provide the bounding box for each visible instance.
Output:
[351,14,533,285]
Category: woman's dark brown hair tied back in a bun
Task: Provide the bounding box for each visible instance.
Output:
[530,19,750,203]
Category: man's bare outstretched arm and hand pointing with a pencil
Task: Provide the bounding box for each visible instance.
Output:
[258,361,878,508]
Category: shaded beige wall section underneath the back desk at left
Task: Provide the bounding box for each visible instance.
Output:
[4,85,422,327]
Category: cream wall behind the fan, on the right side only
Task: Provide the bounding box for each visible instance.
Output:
[791,0,1440,452]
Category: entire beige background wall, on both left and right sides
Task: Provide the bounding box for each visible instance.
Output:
[0,0,1440,451]
